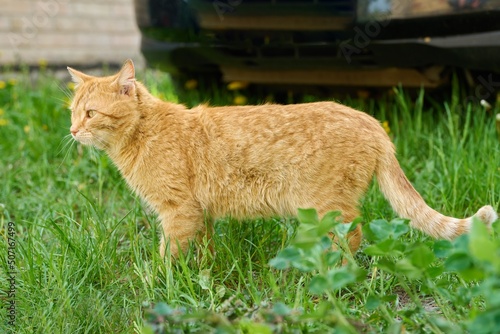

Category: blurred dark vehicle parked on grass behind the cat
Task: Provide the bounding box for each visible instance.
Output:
[140,0,500,87]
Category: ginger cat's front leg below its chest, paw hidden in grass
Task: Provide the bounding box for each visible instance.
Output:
[160,203,207,259]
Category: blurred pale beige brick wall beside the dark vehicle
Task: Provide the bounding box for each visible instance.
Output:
[0,0,144,66]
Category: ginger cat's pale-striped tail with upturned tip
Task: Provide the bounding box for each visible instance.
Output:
[376,150,498,239]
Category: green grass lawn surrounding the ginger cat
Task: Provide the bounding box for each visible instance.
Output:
[0,71,500,333]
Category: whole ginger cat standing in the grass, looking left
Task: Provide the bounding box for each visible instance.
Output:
[68,60,497,257]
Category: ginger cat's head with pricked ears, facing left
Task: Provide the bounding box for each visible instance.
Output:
[68,60,140,149]
